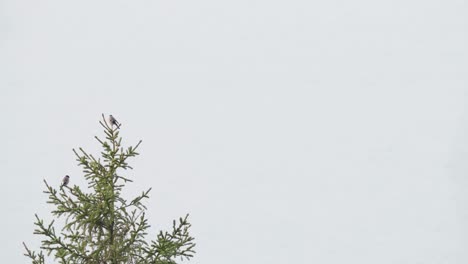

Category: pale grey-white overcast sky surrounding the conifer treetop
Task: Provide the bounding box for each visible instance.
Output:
[0,0,468,264]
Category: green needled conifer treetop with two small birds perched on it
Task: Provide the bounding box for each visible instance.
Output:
[23,115,195,264]
